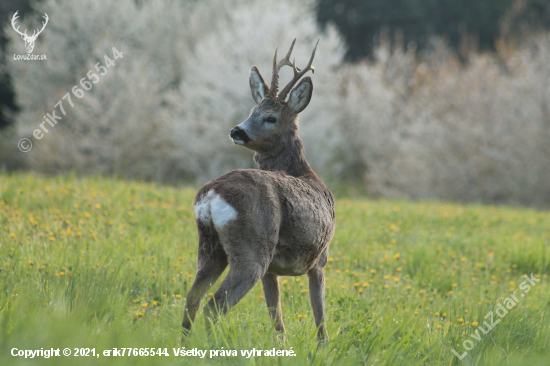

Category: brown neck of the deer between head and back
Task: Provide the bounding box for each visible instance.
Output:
[254,130,315,178]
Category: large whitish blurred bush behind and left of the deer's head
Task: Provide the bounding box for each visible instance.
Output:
[5,0,343,183]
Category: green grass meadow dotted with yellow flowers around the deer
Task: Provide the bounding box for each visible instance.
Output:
[0,174,550,365]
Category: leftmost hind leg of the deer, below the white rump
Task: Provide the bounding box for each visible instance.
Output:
[182,228,227,333]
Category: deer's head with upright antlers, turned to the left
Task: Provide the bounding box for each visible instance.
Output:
[230,39,319,156]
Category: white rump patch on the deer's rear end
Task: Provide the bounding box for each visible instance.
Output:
[195,190,237,229]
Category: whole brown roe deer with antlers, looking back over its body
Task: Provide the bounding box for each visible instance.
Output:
[182,40,335,340]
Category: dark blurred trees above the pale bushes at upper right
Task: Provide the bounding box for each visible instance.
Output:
[316,0,550,61]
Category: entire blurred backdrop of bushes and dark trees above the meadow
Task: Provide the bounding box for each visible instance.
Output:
[0,0,550,207]
